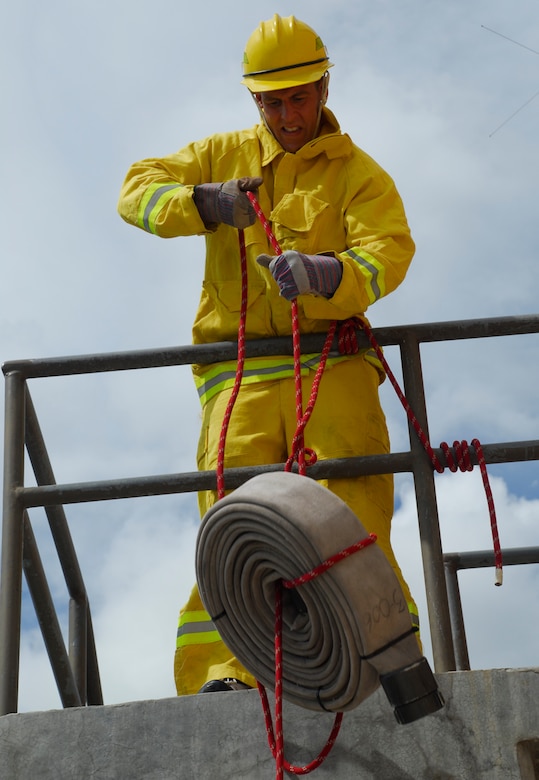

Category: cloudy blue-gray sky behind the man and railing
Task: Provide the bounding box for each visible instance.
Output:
[0,0,539,711]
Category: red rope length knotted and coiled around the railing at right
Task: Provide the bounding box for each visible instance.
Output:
[339,318,503,585]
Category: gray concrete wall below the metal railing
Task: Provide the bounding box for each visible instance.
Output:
[0,669,539,780]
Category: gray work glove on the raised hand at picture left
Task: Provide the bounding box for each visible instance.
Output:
[194,176,262,230]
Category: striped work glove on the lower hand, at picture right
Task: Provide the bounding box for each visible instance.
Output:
[256,249,342,301]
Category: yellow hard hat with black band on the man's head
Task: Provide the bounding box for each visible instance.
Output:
[242,14,332,92]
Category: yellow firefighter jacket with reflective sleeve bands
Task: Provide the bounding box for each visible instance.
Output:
[118,108,414,400]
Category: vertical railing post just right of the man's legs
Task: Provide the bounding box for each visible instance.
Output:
[401,332,455,672]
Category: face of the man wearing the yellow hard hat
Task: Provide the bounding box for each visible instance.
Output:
[256,82,322,153]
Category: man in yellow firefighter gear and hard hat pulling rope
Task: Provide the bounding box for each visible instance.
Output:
[118,15,418,695]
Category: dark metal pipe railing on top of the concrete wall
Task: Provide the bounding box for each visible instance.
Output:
[0,315,539,715]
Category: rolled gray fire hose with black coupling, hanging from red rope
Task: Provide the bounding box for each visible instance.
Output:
[196,472,443,723]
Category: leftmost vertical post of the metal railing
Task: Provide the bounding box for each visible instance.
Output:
[0,371,26,715]
